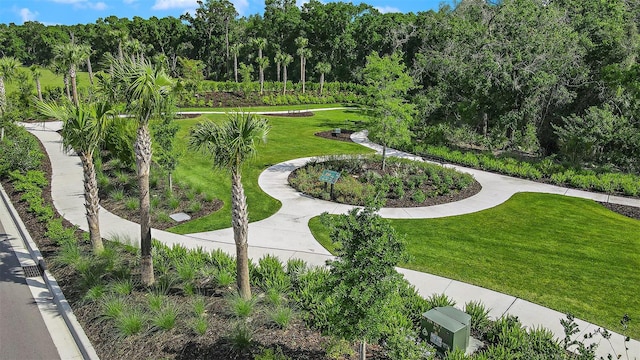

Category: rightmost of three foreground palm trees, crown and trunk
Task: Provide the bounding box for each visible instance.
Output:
[189,112,270,299]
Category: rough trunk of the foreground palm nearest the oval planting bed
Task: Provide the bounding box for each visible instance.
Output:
[231,169,251,299]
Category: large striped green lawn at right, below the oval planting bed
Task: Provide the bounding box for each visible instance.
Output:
[310,193,640,338]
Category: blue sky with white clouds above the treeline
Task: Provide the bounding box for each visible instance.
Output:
[0,0,451,25]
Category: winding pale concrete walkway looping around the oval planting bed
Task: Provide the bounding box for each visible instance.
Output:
[24,121,640,359]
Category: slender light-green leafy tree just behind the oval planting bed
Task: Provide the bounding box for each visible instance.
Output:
[362,52,415,169]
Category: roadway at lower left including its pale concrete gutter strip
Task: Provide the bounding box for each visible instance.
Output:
[0,186,82,360]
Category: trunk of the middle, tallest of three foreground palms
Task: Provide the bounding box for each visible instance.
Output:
[135,122,155,286]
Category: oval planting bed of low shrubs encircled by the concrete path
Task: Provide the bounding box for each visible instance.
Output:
[289,156,481,207]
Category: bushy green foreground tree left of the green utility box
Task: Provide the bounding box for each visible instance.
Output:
[323,206,408,360]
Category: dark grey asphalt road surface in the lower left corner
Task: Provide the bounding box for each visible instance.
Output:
[0,222,60,360]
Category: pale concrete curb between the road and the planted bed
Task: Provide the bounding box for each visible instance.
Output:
[0,185,100,360]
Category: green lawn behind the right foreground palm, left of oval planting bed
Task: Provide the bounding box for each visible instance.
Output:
[171,110,372,234]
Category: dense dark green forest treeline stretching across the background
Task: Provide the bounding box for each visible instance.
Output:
[0,0,640,173]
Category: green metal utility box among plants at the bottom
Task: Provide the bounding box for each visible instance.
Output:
[422,306,471,354]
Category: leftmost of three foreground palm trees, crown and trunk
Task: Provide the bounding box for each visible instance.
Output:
[36,100,115,254]
